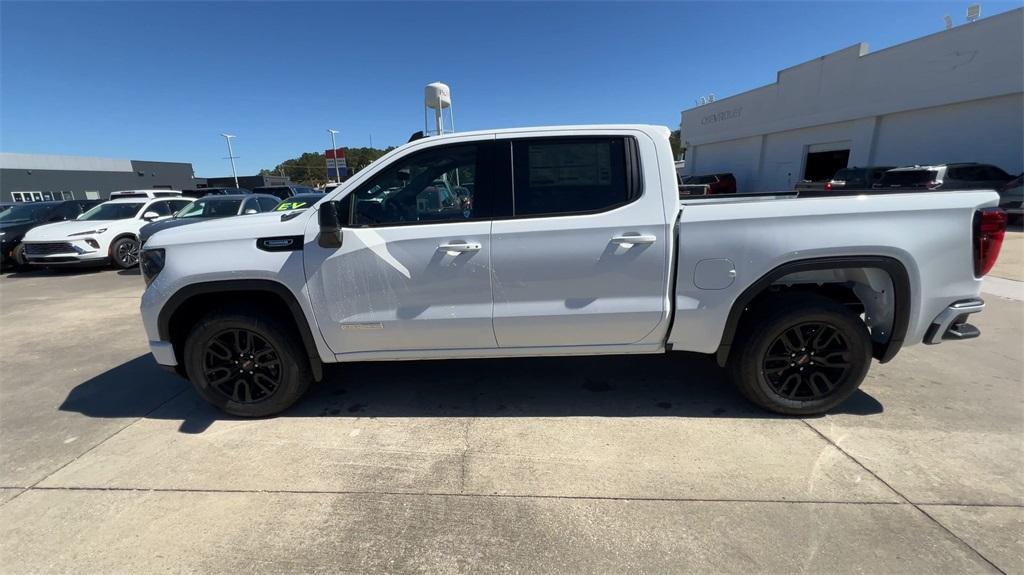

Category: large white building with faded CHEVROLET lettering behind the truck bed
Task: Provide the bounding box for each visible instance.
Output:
[680,8,1024,192]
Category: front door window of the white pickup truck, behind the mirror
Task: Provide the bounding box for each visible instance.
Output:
[351,144,479,226]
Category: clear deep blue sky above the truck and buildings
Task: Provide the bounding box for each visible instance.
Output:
[0,1,1021,176]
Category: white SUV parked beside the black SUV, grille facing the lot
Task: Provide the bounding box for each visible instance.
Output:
[23,197,191,268]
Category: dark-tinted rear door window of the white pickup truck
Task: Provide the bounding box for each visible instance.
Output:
[512,137,639,217]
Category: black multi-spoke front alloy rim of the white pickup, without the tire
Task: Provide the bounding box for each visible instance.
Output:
[203,328,284,404]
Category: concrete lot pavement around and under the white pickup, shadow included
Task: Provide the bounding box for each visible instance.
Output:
[0,235,1024,573]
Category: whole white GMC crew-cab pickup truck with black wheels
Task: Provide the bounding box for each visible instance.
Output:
[140,126,1006,416]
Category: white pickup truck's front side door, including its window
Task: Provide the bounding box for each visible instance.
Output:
[304,136,497,354]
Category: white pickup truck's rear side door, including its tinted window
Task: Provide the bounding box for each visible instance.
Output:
[490,136,671,348]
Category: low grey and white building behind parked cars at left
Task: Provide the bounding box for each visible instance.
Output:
[0,153,199,203]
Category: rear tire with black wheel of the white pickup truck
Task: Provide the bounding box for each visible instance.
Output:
[728,294,871,415]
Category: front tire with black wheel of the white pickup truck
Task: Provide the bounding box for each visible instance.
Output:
[183,310,313,417]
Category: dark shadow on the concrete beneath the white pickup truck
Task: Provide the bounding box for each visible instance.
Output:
[60,353,883,433]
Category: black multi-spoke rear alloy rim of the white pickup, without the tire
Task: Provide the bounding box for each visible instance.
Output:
[762,322,851,401]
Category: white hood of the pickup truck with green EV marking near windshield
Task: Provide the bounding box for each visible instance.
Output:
[145,210,315,248]
